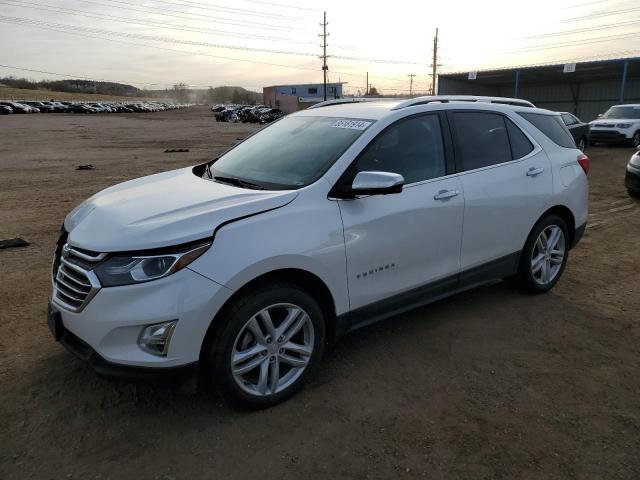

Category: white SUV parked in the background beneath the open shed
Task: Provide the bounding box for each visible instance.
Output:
[589,104,640,147]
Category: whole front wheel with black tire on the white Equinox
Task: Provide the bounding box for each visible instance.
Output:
[207,283,325,410]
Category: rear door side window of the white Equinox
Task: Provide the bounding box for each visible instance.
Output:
[452,112,511,171]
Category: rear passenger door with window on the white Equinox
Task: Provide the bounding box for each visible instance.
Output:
[448,110,553,288]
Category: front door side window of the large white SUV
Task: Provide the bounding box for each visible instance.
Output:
[350,115,445,184]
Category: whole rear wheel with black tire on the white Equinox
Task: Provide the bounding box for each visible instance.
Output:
[516,215,570,294]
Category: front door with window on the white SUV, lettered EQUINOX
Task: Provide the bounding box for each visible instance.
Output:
[338,113,464,324]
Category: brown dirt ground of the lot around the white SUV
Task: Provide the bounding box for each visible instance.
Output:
[0,107,640,480]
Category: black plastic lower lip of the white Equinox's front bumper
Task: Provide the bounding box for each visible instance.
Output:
[48,307,198,386]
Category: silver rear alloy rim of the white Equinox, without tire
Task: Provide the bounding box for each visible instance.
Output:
[531,225,566,285]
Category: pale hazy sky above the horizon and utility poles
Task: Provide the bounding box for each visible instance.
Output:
[0,0,640,94]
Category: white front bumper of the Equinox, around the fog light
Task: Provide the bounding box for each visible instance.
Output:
[52,267,233,370]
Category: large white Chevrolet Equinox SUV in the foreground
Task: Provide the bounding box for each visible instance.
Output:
[49,97,589,408]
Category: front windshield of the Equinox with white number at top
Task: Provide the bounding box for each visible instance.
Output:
[210,116,373,190]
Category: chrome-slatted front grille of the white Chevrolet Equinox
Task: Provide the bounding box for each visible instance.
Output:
[53,243,107,312]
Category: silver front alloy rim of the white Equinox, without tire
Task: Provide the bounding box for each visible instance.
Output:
[230,303,315,397]
